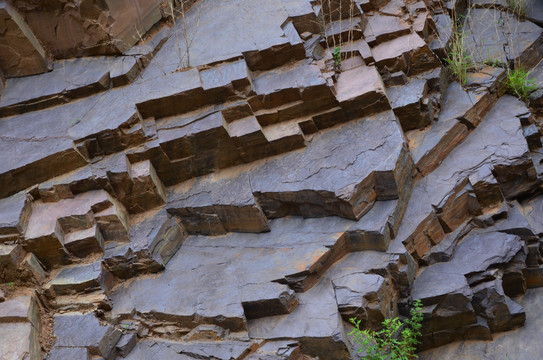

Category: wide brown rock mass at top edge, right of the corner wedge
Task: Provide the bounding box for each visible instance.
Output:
[12,0,162,59]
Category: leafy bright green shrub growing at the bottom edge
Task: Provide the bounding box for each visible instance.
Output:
[349,300,423,360]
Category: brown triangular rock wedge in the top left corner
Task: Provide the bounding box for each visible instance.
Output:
[0,1,51,78]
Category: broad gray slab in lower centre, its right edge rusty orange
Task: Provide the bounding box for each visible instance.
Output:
[111,207,400,330]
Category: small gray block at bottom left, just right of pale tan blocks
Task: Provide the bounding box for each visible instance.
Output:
[54,313,121,359]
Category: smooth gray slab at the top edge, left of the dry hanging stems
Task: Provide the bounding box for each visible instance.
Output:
[142,0,303,80]
